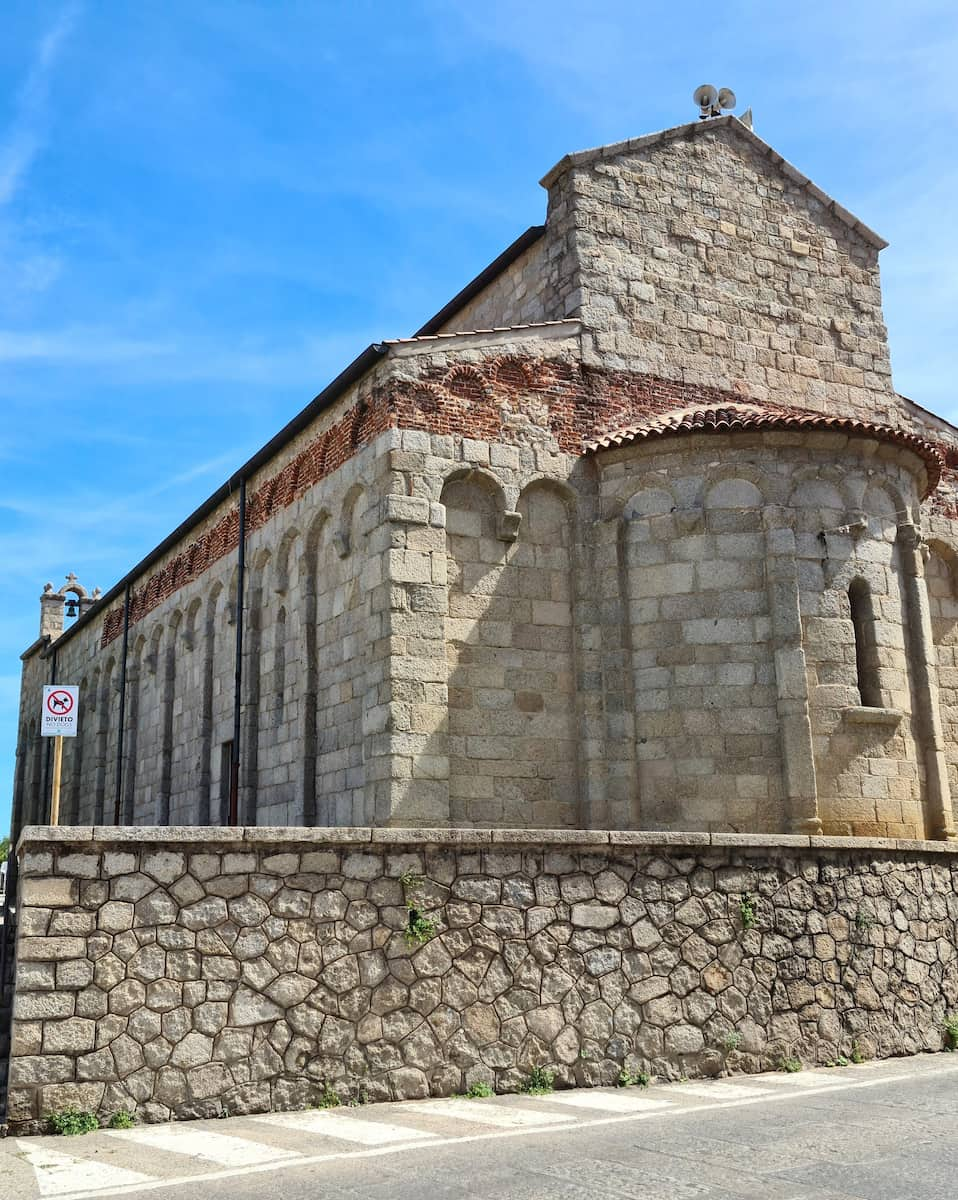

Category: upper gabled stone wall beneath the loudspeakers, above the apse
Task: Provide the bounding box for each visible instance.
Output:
[544,119,897,420]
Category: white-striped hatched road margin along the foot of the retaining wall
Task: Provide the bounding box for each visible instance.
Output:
[0,1063,958,1200]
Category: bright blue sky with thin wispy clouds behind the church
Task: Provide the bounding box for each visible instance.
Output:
[0,0,958,829]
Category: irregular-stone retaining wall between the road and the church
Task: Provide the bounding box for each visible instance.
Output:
[8,828,958,1132]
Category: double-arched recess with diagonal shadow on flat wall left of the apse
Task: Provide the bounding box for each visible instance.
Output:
[441,470,580,828]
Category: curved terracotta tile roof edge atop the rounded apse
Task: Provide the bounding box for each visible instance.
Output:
[586,403,944,496]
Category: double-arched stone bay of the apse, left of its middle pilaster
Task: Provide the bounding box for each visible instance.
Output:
[619,466,783,832]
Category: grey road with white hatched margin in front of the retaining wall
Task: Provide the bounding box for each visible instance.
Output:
[0,1054,958,1200]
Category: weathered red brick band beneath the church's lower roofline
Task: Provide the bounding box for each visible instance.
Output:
[102,354,954,646]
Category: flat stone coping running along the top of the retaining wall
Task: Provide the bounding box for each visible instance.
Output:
[17,826,958,854]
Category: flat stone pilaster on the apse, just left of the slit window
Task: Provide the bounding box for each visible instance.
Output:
[765,508,821,834]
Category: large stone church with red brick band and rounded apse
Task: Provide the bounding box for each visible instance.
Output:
[14,116,958,838]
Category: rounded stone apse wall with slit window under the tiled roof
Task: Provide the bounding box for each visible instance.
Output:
[597,430,926,836]
